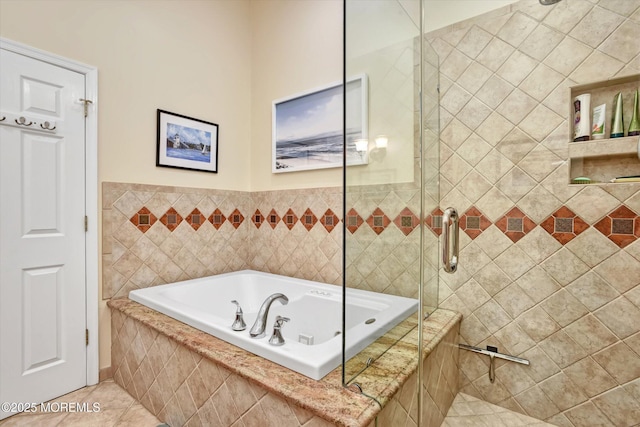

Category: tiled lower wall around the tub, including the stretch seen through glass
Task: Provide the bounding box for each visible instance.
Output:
[102,182,436,299]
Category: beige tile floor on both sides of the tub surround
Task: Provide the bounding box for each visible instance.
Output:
[0,380,553,427]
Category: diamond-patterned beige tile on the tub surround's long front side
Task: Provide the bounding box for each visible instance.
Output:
[112,304,340,427]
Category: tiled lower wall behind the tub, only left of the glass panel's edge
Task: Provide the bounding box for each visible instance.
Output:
[102,183,342,299]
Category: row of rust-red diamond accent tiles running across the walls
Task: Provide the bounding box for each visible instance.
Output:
[130,205,640,248]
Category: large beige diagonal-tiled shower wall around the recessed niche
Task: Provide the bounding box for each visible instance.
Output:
[429,0,640,427]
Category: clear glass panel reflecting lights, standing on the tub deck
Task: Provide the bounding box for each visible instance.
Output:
[343,0,439,410]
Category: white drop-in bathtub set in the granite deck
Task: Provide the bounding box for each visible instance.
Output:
[129,270,418,380]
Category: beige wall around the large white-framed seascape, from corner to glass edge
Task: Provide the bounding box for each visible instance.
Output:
[250,0,342,191]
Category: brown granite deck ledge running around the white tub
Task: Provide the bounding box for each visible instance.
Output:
[108,298,461,427]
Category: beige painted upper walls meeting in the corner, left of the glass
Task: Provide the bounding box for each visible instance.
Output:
[0,0,342,368]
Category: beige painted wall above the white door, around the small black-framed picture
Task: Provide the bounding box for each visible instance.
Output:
[0,0,251,190]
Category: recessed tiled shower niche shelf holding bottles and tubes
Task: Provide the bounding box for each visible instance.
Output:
[569,74,640,185]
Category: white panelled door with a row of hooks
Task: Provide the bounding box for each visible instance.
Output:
[0,50,87,419]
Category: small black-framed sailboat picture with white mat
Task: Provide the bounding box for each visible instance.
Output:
[156,110,218,173]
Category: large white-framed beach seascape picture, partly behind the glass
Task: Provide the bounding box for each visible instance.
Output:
[271,74,368,173]
